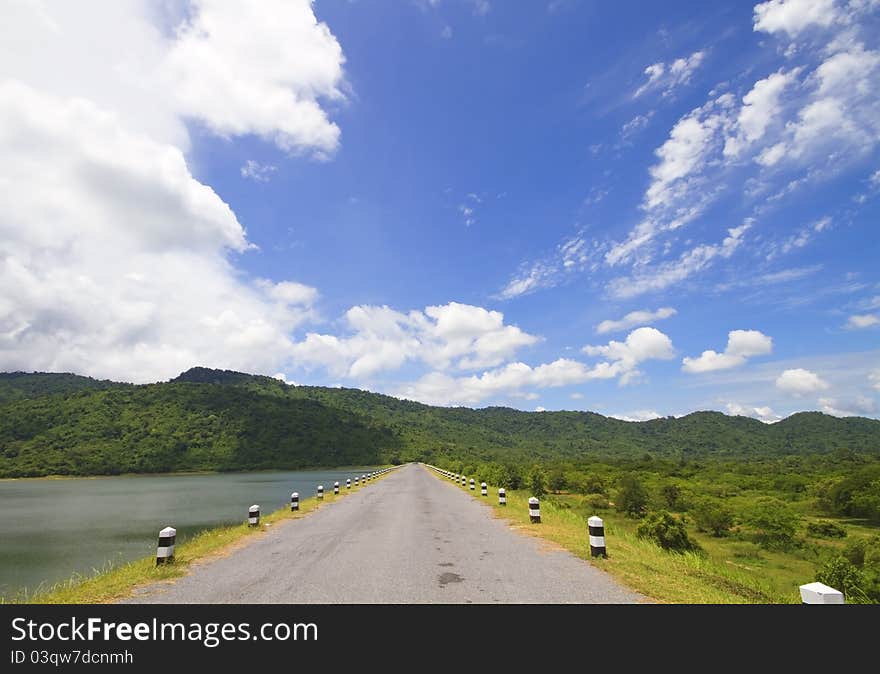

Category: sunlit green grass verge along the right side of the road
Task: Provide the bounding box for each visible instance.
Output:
[437,468,796,604]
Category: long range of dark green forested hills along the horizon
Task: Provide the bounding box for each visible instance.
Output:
[0,368,880,477]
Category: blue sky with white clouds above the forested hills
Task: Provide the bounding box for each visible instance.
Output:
[0,0,880,422]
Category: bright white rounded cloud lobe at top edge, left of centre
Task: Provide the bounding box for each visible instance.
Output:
[163,0,345,156]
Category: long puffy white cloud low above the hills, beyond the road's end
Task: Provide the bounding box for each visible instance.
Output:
[292,302,538,379]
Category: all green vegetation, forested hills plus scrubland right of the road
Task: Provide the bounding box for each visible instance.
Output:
[0,368,880,602]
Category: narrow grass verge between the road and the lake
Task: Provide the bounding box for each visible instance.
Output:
[6,473,387,604]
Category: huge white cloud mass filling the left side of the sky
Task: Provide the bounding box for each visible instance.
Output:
[0,0,343,382]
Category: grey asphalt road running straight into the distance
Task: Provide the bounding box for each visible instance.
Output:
[129,464,642,604]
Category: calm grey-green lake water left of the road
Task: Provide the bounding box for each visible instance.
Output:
[0,466,373,597]
